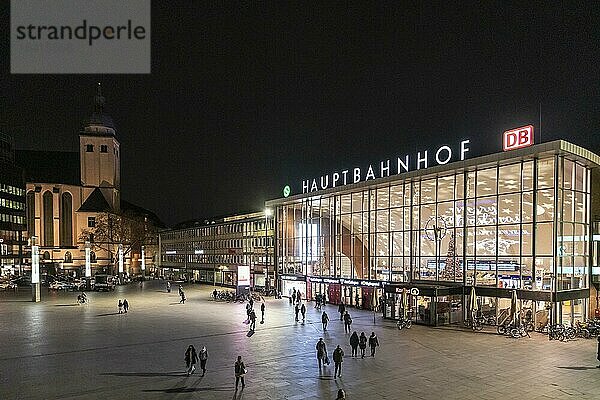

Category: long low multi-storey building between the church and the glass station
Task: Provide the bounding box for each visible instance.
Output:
[159,212,275,288]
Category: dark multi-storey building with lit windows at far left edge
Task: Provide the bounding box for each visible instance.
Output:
[0,133,27,275]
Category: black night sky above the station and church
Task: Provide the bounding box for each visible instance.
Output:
[0,0,600,225]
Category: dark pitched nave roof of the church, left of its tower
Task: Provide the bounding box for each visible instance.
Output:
[15,150,81,185]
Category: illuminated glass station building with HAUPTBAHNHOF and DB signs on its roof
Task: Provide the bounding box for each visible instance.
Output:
[267,133,600,326]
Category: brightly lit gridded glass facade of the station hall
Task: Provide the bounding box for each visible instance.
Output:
[268,142,597,321]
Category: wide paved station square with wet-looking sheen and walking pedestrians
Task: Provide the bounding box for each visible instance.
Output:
[0,281,600,400]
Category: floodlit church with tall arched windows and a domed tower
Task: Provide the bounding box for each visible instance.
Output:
[16,85,162,275]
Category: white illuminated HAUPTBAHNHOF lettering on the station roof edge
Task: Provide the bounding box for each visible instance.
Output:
[302,140,470,193]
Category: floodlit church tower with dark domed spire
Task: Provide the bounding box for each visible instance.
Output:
[79,83,121,210]
